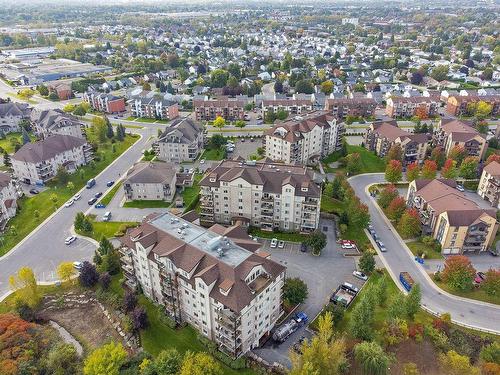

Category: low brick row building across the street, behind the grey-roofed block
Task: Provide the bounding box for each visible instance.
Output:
[193,98,246,121]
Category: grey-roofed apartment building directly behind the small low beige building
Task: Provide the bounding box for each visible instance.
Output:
[153,117,204,163]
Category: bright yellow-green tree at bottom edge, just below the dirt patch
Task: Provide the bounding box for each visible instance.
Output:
[83,342,127,375]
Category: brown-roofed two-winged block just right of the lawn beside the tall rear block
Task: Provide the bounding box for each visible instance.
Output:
[364,121,430,165]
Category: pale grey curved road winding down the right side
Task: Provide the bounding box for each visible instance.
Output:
[349,173,500,333]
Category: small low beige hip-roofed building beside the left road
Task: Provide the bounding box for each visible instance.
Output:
[123,162,177,202]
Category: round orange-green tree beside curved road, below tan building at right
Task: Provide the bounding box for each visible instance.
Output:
[441,255,476,290]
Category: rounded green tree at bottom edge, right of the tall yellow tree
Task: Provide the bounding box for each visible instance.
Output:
[354,341,393,375]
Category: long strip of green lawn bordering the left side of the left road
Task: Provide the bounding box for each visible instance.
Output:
[0,135,138,256]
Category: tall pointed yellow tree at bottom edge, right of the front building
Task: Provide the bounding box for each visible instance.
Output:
[290,311,348,375]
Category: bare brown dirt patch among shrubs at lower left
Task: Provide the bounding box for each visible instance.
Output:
[39,302,123,350]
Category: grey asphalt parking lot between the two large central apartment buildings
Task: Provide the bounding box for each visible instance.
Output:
[253,220,363,366]
